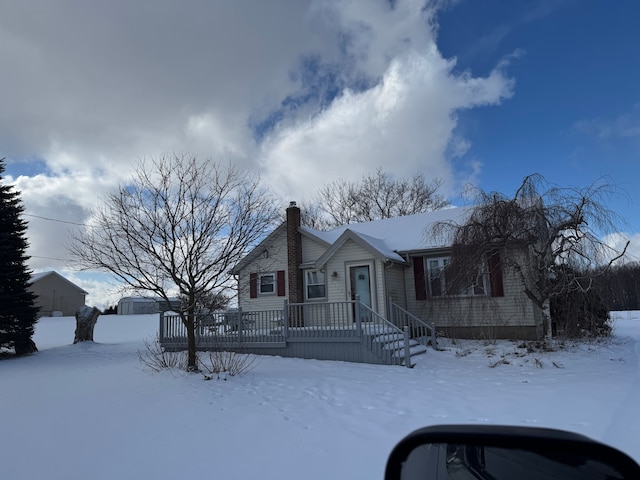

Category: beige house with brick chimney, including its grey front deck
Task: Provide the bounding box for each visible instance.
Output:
[159,202,543,367]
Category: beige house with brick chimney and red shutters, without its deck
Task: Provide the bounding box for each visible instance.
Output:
[234,202,542,339]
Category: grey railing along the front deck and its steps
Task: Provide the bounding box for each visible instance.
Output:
[160,298,435,365]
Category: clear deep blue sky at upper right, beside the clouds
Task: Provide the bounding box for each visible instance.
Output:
[438,0,640,227]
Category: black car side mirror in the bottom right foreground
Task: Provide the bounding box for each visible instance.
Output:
[385,425,640,480]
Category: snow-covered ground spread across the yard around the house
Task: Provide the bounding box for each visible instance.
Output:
[0,312,640,480]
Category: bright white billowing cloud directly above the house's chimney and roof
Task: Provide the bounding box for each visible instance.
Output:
[262,47,512,198]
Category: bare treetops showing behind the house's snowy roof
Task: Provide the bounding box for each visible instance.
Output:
[302,169,449,229]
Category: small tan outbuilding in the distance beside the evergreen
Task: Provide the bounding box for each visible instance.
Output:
[29,271,87,317]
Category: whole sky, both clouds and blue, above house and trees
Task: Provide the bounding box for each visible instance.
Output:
[0,0,640,303]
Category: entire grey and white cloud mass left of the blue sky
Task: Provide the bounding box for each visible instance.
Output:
[0,0,513,304]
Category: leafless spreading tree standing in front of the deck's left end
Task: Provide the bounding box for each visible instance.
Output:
[70,156,277,370]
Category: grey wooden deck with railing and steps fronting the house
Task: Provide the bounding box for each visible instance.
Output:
[160,300,435,366]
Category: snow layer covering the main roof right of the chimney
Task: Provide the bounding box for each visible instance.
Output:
[301,207,471,259]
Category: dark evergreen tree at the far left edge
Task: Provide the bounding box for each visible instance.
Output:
[0,158,38,355]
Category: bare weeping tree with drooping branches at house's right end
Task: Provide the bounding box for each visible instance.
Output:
[436,174,628,340]
